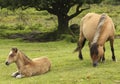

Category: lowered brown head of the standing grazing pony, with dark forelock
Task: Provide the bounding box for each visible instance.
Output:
[90,43,104,67]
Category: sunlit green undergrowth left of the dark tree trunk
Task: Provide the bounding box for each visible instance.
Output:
[0,8,56,38]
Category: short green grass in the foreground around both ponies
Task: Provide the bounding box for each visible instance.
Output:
[0,39,120,84]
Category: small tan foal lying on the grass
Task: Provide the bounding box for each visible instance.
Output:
[5,48,51,78]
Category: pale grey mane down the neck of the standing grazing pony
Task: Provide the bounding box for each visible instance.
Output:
[91,13,107,45]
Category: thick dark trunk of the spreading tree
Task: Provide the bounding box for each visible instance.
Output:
[57,15,69,34]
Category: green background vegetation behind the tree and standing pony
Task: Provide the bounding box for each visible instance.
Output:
[0,4,120,41]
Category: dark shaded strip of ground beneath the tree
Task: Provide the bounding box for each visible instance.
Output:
[4,31,78,42]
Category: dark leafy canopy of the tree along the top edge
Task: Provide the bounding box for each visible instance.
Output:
[0,0,102,9]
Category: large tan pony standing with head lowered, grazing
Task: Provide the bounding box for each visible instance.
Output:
[75,13,116,66]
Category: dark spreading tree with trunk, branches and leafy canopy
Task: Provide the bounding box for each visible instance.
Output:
[0,0,102,34]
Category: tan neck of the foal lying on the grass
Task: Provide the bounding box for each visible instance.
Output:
[16,51,32,69]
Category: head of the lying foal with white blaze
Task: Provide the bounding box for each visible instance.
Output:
[5,48,18,65]
